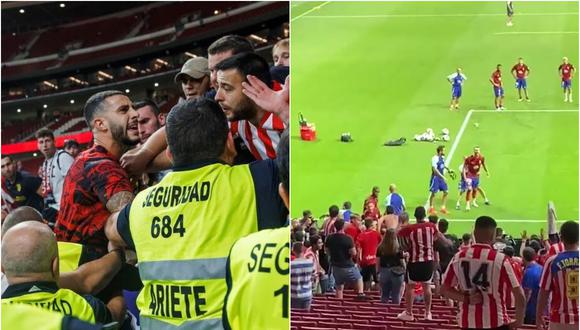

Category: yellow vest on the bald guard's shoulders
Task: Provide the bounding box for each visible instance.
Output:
[2,289,95,323]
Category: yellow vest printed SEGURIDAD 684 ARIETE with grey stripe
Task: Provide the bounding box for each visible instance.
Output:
[129,164,258,329]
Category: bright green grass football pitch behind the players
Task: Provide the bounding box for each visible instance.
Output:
[291,2,579,236]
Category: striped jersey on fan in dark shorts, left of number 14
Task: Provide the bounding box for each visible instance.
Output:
[398,222,438,262]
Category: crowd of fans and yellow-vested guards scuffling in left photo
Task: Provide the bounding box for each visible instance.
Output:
[2,35,290,329]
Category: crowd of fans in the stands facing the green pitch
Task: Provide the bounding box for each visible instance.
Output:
[291,196,579,329]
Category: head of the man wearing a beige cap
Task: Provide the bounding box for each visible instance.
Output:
[174,57,209,100]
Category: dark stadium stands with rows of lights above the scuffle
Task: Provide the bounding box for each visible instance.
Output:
[2,1,289,173]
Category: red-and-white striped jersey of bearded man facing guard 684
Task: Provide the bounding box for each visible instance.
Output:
[230,112,286,160]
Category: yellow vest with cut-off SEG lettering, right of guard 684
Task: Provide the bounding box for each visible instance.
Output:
[224,227,290,330]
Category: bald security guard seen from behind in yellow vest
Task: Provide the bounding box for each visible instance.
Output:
[2,221,112,323]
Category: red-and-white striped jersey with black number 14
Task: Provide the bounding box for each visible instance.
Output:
[443,243,520,329]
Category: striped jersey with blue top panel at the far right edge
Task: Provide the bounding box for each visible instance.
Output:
[540,250,578,324]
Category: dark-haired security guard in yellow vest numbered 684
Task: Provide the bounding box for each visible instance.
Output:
[105,96,287,329]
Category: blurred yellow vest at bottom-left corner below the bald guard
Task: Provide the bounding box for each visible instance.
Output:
[2,304,103,330]
